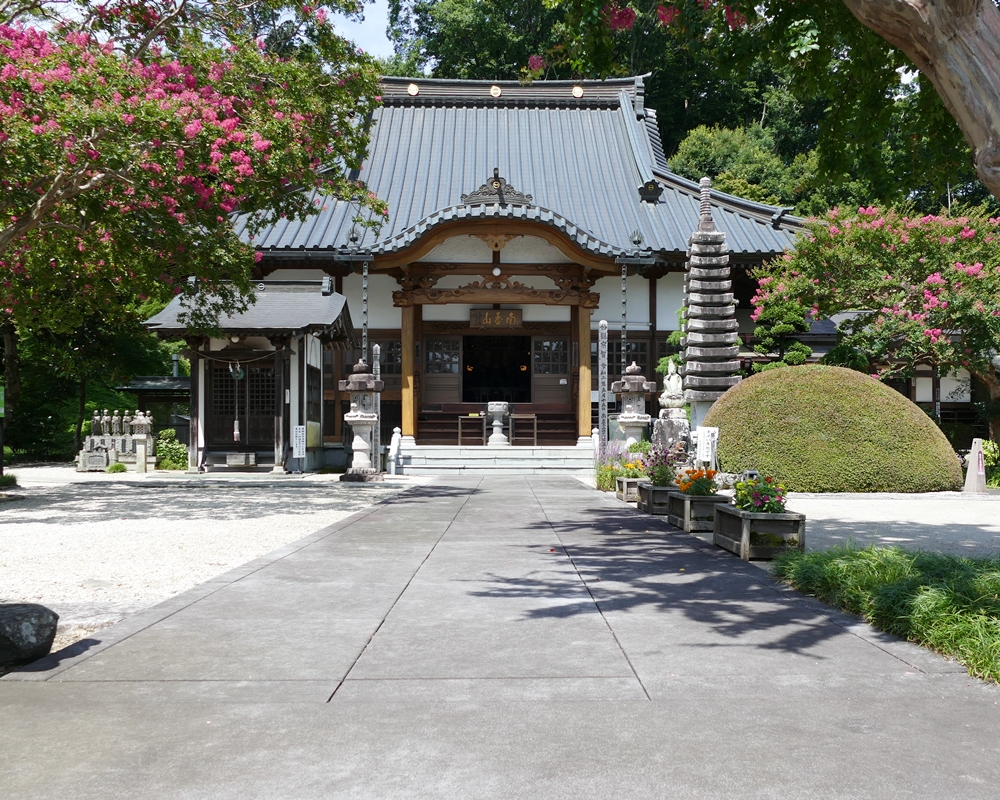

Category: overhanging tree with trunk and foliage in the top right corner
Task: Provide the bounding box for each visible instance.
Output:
[544,0,1000,206]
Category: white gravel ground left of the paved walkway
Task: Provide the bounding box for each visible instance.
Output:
[0,467,424,649]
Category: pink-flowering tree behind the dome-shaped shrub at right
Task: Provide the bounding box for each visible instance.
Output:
[753,207,1000,439]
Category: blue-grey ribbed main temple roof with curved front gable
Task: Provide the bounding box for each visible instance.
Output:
[246,77,797,257]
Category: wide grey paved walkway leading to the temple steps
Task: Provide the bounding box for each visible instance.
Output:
[0,477,1000,800]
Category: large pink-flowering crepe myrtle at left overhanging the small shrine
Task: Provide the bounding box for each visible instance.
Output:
[0,0,386,418]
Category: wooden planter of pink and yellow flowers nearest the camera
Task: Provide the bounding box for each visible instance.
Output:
[712,477,806,561]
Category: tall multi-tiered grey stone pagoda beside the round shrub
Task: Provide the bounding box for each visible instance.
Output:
[681,178,740,429]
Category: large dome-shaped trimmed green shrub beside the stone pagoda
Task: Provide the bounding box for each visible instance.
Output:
[703,364,962,492]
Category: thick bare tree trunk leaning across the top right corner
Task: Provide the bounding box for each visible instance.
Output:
[844,0,1000,199]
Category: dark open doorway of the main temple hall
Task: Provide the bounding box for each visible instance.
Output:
[462,336,532,403]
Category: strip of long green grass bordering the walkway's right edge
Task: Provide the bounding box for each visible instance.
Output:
[774,546,1000,683]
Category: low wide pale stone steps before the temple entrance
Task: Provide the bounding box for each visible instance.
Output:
[400,445,594,477]
